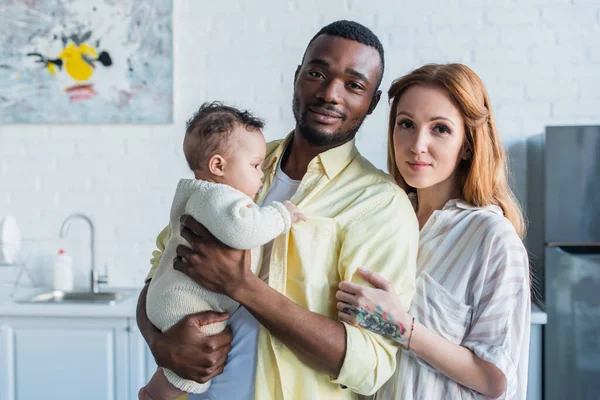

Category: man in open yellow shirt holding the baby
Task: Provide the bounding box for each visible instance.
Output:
[138,21,418,399]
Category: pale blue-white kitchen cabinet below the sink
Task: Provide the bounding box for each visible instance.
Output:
[0,317,156,400]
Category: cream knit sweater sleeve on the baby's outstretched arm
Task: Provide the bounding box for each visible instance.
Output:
[185,185,291,250]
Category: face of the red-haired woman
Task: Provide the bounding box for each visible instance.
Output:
[394,85,465,193]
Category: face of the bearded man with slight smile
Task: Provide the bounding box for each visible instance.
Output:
[293,35,381,146]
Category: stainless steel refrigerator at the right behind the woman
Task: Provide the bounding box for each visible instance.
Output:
[527,126,600,400]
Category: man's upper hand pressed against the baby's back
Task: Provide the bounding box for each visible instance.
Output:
[173,215,252,300]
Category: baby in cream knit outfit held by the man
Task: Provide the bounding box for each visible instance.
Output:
[139,103,305,400]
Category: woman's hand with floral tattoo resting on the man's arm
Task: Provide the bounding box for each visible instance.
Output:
[336,268,412,345]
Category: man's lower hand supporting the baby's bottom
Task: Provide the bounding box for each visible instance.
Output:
[150,311,233,383]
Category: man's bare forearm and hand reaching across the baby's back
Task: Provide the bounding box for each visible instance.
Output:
[174,216,346,377]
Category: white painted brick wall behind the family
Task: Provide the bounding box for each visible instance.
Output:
[0,0,600,286]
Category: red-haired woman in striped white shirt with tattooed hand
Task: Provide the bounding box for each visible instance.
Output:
[337,64,530,400]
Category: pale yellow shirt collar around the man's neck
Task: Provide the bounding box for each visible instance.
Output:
[264,131,358,179]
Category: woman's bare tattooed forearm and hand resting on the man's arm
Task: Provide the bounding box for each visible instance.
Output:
[336,269,506,397]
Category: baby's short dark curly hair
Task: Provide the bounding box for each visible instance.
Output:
[183,101,265,170]
